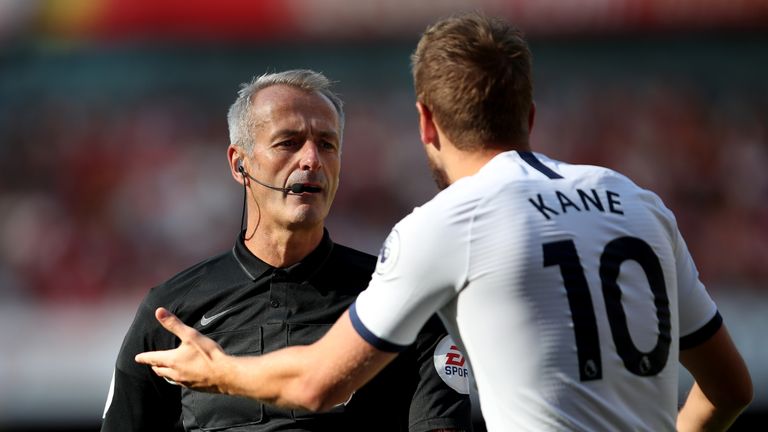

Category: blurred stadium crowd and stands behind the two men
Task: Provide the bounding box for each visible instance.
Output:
[0,0,768,431]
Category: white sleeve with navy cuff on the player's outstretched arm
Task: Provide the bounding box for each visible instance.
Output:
[350,207,467,351]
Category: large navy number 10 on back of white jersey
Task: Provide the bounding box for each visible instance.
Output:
[543,237,672,381]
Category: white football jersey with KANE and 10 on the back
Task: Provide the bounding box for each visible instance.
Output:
[350,152,722,431]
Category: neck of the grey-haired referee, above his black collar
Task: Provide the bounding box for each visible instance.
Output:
[245,224,323,268]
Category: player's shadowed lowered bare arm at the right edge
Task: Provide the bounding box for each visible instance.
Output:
[677,325,753,431]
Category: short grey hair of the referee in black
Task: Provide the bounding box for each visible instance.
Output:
[227,69,344,153]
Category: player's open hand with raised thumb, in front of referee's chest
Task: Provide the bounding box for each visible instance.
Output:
[135,308,227,393]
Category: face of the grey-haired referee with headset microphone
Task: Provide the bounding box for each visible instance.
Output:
[248,85,341,230]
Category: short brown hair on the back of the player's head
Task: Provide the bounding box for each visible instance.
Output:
[411,13,533,149]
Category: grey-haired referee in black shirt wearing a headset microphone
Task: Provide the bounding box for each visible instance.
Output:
[102,70,471,432]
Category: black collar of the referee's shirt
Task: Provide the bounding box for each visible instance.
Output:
[232,229,333,281]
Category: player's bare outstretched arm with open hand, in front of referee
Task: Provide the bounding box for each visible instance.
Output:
[136,308,397,411]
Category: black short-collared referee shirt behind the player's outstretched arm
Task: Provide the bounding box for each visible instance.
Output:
[102,231,471,431]
